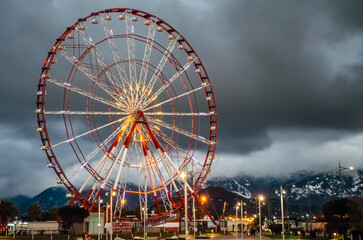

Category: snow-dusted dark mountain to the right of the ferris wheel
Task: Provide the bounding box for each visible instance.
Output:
[205,171,363,217]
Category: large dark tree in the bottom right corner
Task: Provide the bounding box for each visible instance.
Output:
[323,197,363,235]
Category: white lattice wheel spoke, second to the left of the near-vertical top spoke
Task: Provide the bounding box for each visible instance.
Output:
[76,27,120,89]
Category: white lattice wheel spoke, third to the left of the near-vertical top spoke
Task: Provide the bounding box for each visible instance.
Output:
[59,50,122,104]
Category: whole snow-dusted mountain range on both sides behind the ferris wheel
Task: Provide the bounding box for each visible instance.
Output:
[8,171,363,218]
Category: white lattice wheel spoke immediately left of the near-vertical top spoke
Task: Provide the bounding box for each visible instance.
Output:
[100,14,129,88]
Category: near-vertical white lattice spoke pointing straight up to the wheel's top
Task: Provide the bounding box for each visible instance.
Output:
[125,12,137,84]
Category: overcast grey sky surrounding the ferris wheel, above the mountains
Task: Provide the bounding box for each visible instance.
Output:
[0,0,363,197]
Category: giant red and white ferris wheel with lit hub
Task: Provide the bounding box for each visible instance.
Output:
[36,8,218,221]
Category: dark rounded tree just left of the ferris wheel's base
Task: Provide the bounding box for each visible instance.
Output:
[58,206,89,235]
